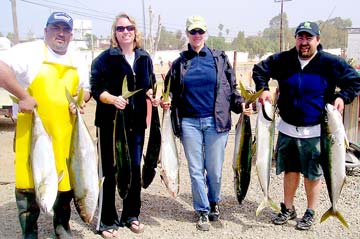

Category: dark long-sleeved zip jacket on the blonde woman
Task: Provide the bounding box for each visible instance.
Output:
[90,47,155,128]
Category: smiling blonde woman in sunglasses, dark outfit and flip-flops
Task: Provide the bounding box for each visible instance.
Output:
[90,13,156,238]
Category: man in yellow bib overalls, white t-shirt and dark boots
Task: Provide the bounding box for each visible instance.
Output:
[3,12,90,239]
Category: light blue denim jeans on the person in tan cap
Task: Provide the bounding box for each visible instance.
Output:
[181,117,229,213]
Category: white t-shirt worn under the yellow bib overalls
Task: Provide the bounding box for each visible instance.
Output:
[0,40,90,91]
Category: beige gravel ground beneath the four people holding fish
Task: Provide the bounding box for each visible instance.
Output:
[0,101,360,239]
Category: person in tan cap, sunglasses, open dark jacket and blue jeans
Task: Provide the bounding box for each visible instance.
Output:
[161,16,251,231]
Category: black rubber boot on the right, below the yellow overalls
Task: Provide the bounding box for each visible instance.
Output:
[53,191,73,239]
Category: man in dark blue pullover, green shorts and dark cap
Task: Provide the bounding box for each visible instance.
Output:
[253,21,360,230]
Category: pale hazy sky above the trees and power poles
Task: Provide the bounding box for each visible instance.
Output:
[0,0,360,38]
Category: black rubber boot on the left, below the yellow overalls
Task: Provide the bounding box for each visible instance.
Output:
[15,189,40,239]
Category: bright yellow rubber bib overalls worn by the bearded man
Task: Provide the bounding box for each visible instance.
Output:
[15,46,79,191]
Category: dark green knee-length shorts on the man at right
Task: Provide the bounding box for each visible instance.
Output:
[275,132,323,181]
